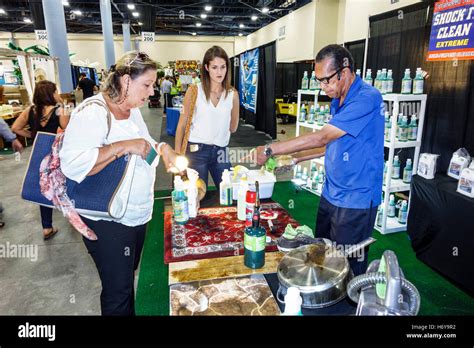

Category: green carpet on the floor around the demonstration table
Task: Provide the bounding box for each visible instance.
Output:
[136,182,474,315]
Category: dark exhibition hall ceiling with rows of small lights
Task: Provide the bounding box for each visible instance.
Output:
[0,0,311,36]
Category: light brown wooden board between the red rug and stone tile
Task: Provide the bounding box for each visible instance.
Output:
[168,251,285,285]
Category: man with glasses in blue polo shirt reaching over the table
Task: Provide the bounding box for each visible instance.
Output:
[257,45,384,275]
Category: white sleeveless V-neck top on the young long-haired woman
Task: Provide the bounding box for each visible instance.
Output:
[189,83,234,147]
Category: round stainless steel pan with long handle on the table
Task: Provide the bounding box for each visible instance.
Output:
[276,238,375,308]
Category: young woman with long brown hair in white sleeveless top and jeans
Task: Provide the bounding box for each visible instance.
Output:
[175,46,239,190]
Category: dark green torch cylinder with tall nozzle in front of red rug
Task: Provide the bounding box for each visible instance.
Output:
[244,181,266,269]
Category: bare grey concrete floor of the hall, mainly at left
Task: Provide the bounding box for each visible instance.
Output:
[0,101,295,315]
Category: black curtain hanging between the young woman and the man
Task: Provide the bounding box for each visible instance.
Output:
[237,42,277,139]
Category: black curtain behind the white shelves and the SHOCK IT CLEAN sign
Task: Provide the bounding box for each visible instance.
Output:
[367,1,474,171]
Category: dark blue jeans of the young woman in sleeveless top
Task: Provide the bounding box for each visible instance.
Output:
[186,142,231,188]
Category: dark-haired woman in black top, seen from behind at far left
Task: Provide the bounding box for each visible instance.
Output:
[12,80,69,240]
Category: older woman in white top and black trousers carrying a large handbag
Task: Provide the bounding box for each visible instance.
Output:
[59,52,179,315]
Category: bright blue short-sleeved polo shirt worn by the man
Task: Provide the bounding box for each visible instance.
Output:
[322,76,384,209]
